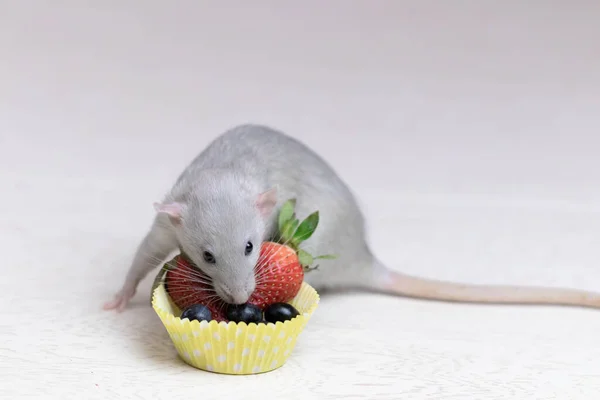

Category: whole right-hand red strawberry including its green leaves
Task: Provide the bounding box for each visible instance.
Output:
[248,200,332,309]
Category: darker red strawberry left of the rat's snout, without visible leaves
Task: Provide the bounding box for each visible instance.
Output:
[164,254,226,321]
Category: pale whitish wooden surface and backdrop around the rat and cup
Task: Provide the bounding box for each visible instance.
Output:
[0,0,600,400]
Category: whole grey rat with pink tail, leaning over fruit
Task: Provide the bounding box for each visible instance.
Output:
[104,124,600,311]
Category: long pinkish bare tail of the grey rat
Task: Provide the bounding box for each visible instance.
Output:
[370,264,600,308]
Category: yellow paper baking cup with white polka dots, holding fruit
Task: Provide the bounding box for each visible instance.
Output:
[152,282,319,375]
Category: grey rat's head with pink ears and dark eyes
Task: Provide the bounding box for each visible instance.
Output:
[156,188,277,304]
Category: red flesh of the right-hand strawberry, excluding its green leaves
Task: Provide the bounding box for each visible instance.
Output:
[248,242,304,309]
